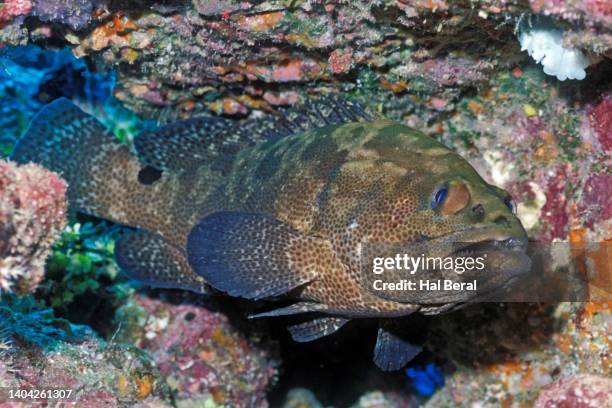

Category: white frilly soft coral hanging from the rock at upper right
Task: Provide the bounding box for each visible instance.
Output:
[519,27,589,81]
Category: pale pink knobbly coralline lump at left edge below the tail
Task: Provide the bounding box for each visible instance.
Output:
[0,161,66,294]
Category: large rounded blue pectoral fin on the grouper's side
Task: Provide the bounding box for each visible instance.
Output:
[187,211,333,299]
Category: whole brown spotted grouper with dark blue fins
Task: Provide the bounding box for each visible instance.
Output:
[11,97,527,370]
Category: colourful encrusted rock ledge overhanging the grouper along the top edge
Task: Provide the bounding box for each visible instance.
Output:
[0,0,612,120]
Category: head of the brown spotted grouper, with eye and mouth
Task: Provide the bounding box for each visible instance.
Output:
[334,125,530,304]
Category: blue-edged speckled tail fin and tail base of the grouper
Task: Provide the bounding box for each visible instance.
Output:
[10,98,145,223]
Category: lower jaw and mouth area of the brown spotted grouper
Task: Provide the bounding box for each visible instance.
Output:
[360,227,531,311]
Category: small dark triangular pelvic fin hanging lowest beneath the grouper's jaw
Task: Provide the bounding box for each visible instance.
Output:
[374,325,423,371]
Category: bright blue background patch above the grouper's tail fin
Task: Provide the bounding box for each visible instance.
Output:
[0,45,145,156]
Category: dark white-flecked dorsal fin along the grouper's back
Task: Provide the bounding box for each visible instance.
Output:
[134,96,375,172]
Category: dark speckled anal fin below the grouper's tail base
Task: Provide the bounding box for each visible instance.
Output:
[115,230,208,293]
